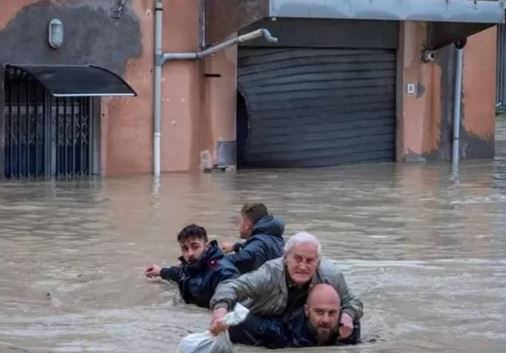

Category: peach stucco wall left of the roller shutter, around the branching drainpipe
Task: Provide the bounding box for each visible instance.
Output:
[0,0,225,175]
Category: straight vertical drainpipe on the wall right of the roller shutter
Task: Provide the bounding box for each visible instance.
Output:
[452,39,466,169]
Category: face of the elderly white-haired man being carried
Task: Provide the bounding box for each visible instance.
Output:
[285,243,318,286]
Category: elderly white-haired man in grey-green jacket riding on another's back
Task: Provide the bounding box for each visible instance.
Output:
[210,232,363,345]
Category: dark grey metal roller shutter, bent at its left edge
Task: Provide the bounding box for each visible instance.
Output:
[238,48,396,167]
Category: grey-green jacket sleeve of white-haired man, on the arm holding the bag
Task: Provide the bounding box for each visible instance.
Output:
[209,264,275,310]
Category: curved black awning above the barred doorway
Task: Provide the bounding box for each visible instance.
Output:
[9,65,137,97]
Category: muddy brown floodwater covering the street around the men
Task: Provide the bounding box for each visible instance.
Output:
[0,121,506,353]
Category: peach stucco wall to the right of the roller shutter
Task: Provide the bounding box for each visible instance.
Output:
[396,22,496,161]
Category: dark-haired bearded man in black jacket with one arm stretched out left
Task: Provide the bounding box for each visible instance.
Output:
[144,224,239,308]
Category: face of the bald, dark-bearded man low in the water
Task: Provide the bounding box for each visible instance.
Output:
[305,299,339,345]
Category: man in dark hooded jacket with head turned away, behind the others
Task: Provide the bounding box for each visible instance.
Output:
[221,203,285,274]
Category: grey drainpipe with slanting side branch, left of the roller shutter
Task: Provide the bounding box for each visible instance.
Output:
[153,8,277,177]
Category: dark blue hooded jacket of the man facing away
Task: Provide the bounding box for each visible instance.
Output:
[227,215,285,274]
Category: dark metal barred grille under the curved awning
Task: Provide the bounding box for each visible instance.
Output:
[4,66,97,178]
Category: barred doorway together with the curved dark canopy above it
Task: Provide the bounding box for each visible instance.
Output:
[3,65,136,178]
